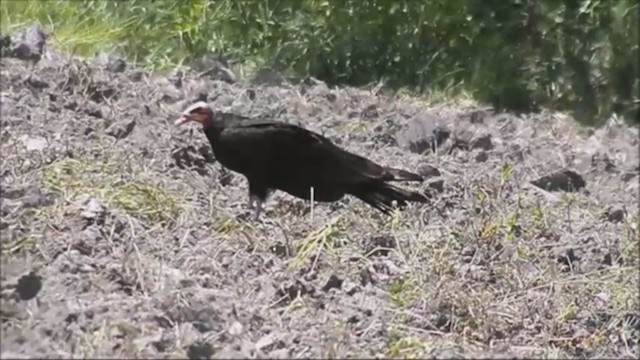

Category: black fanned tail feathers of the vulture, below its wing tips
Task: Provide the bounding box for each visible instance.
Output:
[350,182,429,214]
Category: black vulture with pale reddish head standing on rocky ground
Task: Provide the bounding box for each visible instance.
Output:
[174,101,428,220]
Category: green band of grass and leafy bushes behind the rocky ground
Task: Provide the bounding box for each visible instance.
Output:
[0,0,640,124]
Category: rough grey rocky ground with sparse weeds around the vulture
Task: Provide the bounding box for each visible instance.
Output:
[0,23,640,359]
